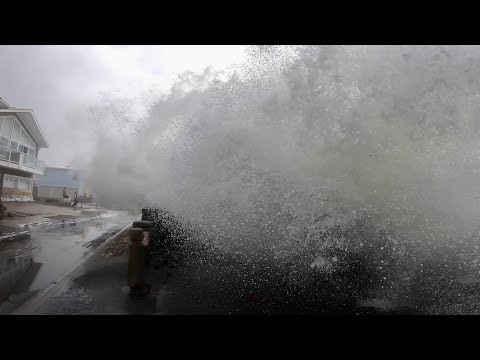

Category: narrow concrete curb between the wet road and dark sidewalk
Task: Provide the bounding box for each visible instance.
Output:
[11,217,140,315]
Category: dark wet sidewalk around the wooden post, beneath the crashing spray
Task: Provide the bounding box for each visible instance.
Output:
[9,217,415,315]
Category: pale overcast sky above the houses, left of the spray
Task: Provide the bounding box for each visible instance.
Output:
[0,45,248,165]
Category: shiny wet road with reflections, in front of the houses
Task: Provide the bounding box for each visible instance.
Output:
[0,212,136,314]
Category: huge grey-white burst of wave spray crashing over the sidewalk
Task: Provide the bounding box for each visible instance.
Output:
[83,46,480,313]
